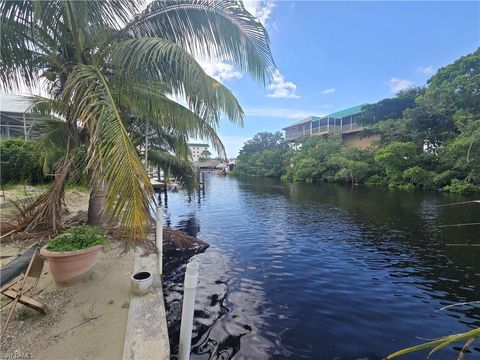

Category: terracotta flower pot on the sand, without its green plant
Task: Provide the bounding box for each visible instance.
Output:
[40,245,102,286]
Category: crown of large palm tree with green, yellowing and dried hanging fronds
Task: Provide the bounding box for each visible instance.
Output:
[0,0,274,245]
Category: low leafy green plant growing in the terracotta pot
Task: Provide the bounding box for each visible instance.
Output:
[47,226,107,252]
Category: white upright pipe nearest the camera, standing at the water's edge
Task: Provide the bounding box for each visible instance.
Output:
[178,262,198,360]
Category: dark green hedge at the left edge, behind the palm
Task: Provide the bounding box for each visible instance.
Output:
[0,139,45,185]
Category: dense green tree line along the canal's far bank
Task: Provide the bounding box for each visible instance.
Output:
[233,49,480,193]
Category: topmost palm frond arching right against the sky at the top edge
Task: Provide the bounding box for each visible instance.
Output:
[126,0,275,84]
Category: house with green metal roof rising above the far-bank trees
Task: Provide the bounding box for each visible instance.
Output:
[282,104,378,148]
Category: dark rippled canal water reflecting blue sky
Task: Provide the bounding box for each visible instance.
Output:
[162,175,480,360]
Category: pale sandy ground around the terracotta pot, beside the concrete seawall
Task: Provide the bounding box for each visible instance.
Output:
[0,190,134,360]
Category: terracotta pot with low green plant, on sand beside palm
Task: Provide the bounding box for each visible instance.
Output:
[40,226,106,286]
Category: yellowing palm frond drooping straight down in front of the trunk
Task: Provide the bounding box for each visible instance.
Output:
[62,65,154,243]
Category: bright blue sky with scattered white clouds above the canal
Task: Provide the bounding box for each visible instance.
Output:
[202,1,480,157]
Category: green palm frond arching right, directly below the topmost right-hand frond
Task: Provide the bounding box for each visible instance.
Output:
[105,37,243,124]
